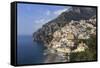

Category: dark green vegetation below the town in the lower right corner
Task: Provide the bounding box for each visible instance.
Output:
[70,35,97,61]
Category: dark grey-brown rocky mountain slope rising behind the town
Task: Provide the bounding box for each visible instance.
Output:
[33,7,96,45]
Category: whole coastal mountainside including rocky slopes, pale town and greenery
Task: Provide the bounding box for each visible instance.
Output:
[33,7,96,63]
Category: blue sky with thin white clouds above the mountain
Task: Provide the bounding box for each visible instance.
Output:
[17,3,70,35]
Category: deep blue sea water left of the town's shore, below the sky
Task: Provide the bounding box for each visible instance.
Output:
[17,36,45,64]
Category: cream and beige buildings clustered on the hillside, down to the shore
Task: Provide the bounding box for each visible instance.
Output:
[44,19,96,63]
